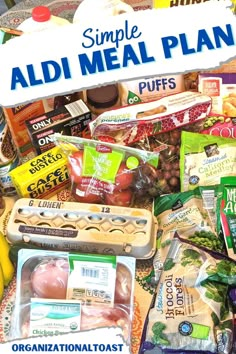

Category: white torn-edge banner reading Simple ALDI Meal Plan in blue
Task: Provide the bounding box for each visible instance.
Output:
[0,0,236,107]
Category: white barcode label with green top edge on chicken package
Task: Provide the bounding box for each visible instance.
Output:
[67,254,116,305]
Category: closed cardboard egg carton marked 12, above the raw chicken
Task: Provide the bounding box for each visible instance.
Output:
[7,198,156,259]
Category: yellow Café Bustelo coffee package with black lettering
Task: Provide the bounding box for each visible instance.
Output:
[9,146,69,199]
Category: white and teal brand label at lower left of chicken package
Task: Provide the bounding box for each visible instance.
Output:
[29,298,81,337]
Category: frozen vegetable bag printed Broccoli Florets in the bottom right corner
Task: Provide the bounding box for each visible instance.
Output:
[140,237,236,354]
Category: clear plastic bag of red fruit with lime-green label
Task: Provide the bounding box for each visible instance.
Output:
[54,134,159,207]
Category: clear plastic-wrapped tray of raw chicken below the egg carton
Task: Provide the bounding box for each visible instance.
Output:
[10,249,135,344]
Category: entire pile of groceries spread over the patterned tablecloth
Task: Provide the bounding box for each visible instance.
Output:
[0,0,236,354]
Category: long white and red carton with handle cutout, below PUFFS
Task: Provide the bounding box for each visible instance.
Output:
[89,91,211,145]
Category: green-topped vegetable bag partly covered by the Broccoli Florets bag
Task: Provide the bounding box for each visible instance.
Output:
[154,185,224,278]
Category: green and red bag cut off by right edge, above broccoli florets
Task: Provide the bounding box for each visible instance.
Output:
[217,176,236,260]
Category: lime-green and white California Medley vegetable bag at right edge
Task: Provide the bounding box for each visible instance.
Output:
[180,131,236,192]
